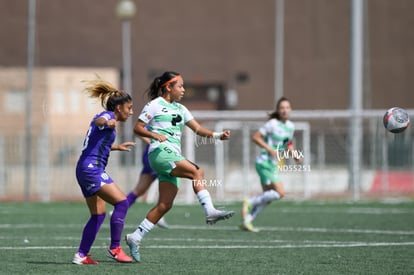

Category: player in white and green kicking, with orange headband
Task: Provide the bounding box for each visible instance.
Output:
[126,72,234,262]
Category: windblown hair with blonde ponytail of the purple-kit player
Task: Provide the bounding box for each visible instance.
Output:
[84,78,132,112]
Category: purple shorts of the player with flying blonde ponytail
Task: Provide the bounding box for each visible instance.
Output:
[76,165,113,198]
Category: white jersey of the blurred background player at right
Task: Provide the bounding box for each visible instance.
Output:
[256,118,295,162]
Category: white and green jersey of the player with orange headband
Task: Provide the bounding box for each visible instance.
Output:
[138,97,194,155]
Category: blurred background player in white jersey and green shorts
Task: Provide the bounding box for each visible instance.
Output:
[241,97,300,232]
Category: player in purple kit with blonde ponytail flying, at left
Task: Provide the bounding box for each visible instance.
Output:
[72,79,135,264]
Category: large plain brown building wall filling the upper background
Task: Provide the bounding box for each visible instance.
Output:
[0,0,414,110]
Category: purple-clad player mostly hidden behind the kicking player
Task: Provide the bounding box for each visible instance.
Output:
[123,137,169,228]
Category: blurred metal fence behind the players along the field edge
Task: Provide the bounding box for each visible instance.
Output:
[0,110,414,203]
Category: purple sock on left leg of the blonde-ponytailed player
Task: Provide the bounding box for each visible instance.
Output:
[78,213,105,257]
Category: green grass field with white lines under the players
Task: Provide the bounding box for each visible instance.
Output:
[0,201,414,274]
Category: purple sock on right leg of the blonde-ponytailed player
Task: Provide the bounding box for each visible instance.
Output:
[109,200,129,249]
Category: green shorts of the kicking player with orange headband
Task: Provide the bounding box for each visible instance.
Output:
[148,144,185,188]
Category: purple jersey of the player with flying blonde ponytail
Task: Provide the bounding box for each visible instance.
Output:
[78,111,116,168]
